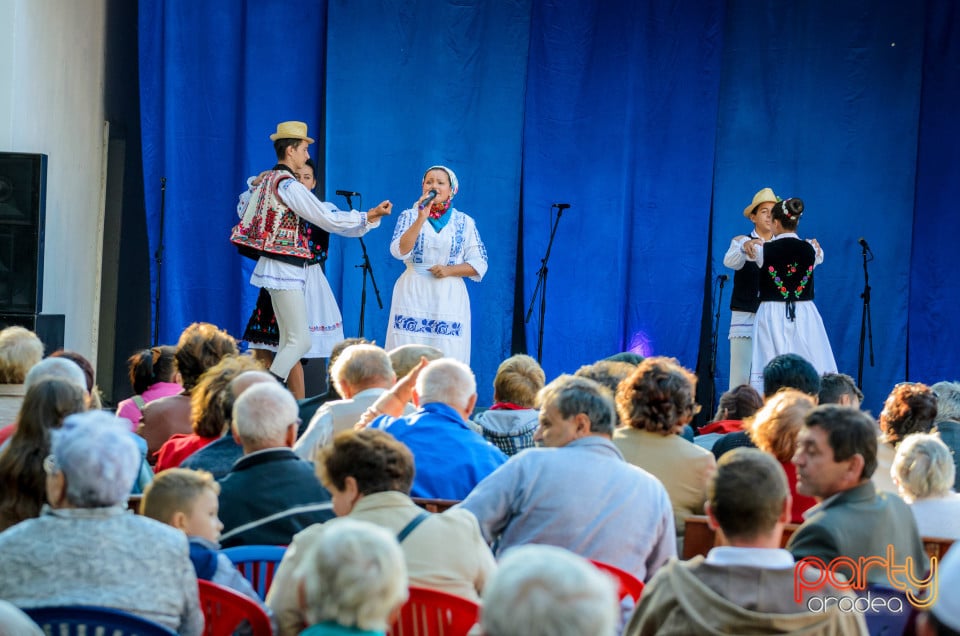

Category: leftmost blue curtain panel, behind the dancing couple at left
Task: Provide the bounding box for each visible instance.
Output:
[139,0,326,343]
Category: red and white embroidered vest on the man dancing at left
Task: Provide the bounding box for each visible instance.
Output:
[230,169,314,265]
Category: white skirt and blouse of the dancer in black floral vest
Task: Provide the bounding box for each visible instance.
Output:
[750,232,837,395]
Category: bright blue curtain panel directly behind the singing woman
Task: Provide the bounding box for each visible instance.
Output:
[325,0,530,398]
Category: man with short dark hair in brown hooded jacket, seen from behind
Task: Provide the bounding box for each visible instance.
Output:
[625,448,867,636]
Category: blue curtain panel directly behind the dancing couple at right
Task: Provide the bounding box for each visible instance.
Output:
[713,0,923,413]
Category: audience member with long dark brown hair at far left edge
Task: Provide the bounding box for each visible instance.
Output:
[0,378,87,530]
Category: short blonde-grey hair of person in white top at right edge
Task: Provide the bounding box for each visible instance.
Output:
[890,433,957,503]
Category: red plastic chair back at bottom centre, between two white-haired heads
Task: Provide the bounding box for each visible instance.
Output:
[387,586,480,636]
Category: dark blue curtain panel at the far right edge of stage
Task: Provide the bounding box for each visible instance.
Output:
[908,0,960,384]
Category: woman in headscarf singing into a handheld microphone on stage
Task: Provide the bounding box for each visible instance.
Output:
[384,166,487,364]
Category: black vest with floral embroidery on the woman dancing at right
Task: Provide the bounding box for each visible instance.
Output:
[760,237,817,303]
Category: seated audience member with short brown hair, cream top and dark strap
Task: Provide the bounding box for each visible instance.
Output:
[267,428,496,636]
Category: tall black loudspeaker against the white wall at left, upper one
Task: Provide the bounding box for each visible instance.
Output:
[0,152,47,316]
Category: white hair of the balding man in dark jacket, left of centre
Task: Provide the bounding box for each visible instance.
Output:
[231,382,298,447]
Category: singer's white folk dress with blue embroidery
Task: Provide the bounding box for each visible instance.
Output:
[385,208,487,365]
